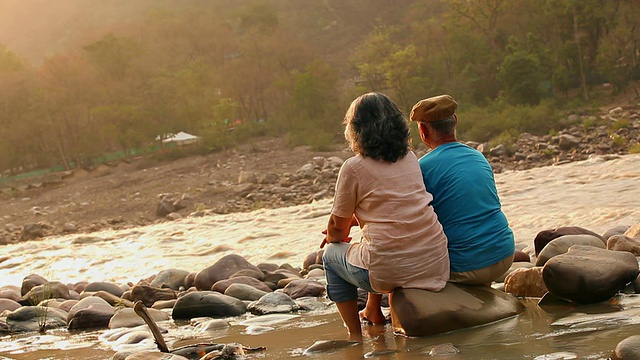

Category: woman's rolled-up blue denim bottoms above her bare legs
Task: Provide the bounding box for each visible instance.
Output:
[322,242,376,302]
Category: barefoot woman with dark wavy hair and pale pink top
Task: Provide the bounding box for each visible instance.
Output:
[321,93,449,340]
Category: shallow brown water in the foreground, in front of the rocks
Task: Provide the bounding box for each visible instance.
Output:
[0,299,640,360]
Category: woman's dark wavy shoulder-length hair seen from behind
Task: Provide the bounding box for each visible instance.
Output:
[344,93,411,163]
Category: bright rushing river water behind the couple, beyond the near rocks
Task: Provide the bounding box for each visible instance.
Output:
[0,155,640,286]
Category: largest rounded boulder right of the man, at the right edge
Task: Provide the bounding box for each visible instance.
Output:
[542,245,638,304]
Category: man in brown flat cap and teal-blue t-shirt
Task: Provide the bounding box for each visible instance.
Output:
[411,95,515,285]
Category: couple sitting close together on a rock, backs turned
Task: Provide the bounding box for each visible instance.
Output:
[323,93,515,340]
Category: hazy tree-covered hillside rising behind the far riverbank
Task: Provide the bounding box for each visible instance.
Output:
[0,0,640,172]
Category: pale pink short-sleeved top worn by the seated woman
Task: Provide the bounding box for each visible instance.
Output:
[331,152,449,292]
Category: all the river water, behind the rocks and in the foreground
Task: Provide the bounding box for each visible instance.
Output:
[0,155,640,360]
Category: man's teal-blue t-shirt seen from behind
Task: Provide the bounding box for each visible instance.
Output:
[419,142,515,272]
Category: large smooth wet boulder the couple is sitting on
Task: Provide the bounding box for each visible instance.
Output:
[391,283,524,336]
